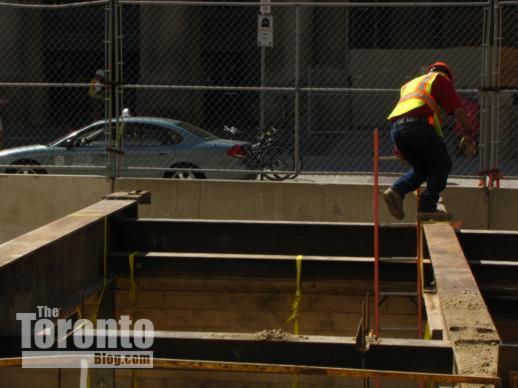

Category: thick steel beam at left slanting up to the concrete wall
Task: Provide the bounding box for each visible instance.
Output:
[0,200,137,335]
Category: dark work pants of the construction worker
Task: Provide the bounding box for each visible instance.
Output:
[390,121,451,211]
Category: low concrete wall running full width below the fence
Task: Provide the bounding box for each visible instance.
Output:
[0,175,518,242]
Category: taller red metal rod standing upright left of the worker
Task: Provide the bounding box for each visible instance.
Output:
[374,128,380,337]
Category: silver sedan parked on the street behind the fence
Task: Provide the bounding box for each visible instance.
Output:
[0,117,256,179]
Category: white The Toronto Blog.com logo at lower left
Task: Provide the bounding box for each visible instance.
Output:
[16,306,155,368]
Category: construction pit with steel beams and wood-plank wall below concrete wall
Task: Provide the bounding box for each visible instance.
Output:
[0,193,518,388]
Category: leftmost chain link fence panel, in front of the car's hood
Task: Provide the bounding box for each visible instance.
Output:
[0,1,106,174]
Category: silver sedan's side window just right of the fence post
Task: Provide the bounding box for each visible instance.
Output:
[124,123,182,146]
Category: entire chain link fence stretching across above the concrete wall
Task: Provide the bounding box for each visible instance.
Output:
[0,0,518,179]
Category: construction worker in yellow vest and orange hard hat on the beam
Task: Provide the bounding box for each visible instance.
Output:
[383,62,476,220]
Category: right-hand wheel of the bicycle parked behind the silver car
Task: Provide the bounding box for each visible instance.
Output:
[260,145,301,181]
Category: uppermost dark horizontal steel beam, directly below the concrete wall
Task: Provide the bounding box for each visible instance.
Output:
[110,219,416,257]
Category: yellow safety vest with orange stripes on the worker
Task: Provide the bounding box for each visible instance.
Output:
[388,72,443,137]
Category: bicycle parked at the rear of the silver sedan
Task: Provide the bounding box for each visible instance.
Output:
[223,126,302,181]
